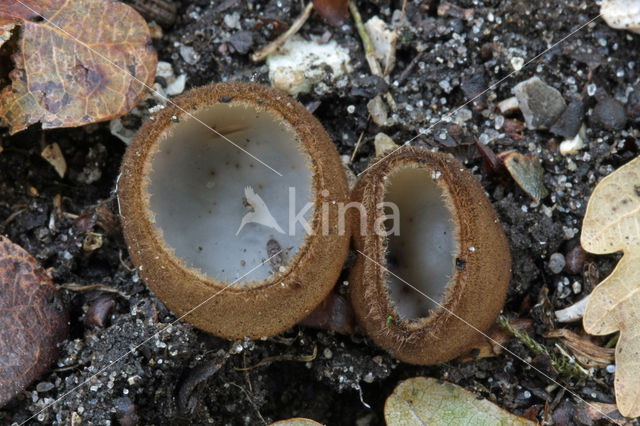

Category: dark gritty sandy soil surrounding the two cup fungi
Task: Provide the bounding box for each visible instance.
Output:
[0,0,640,425]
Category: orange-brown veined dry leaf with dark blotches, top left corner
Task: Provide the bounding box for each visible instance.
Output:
[0,0,157,134]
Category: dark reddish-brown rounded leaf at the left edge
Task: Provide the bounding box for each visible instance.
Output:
[0,236,68,407]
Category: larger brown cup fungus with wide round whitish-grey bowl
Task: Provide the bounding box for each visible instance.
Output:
[118,83,349,338]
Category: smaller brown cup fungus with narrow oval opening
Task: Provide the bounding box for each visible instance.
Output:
[349,147,511,364]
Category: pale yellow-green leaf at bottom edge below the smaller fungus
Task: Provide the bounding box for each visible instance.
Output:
[384,377,536,426]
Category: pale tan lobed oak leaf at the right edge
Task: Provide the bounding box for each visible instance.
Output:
[580,157,640,417]
